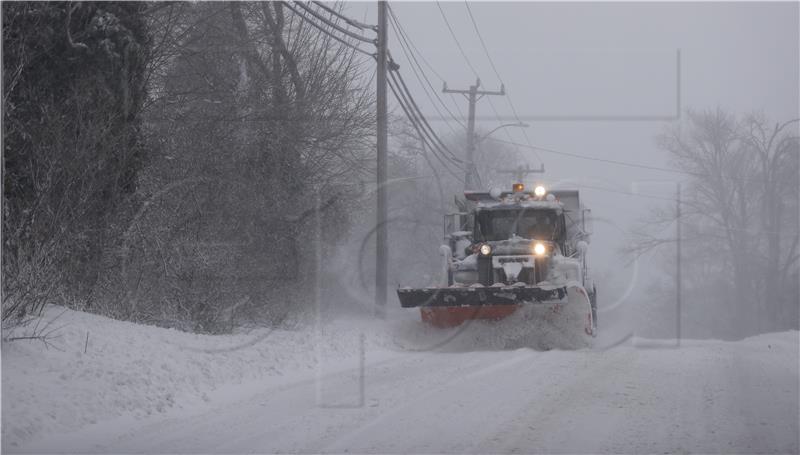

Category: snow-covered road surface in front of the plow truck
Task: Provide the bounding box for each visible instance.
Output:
[4,308,800,453]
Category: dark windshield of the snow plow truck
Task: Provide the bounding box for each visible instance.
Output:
[476,209,562,241]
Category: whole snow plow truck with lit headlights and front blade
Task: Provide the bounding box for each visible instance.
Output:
[397,183,597,336]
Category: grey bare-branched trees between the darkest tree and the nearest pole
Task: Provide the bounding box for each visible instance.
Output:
[100,3,373,331]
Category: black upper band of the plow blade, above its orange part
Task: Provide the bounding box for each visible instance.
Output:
[397,286,567,308]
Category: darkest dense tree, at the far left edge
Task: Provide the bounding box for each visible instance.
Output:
[2,2,148,322]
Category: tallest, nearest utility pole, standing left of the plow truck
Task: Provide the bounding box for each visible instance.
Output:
[375,1,389,317]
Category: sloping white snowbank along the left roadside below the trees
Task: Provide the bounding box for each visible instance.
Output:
[2,307,396,450]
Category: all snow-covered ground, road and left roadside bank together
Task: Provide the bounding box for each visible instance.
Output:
[2,308,800,453]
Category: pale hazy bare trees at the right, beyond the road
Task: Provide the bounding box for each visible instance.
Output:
[629,109,799,333]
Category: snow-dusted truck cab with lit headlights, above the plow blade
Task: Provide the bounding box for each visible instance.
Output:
[445,185,590,285]
